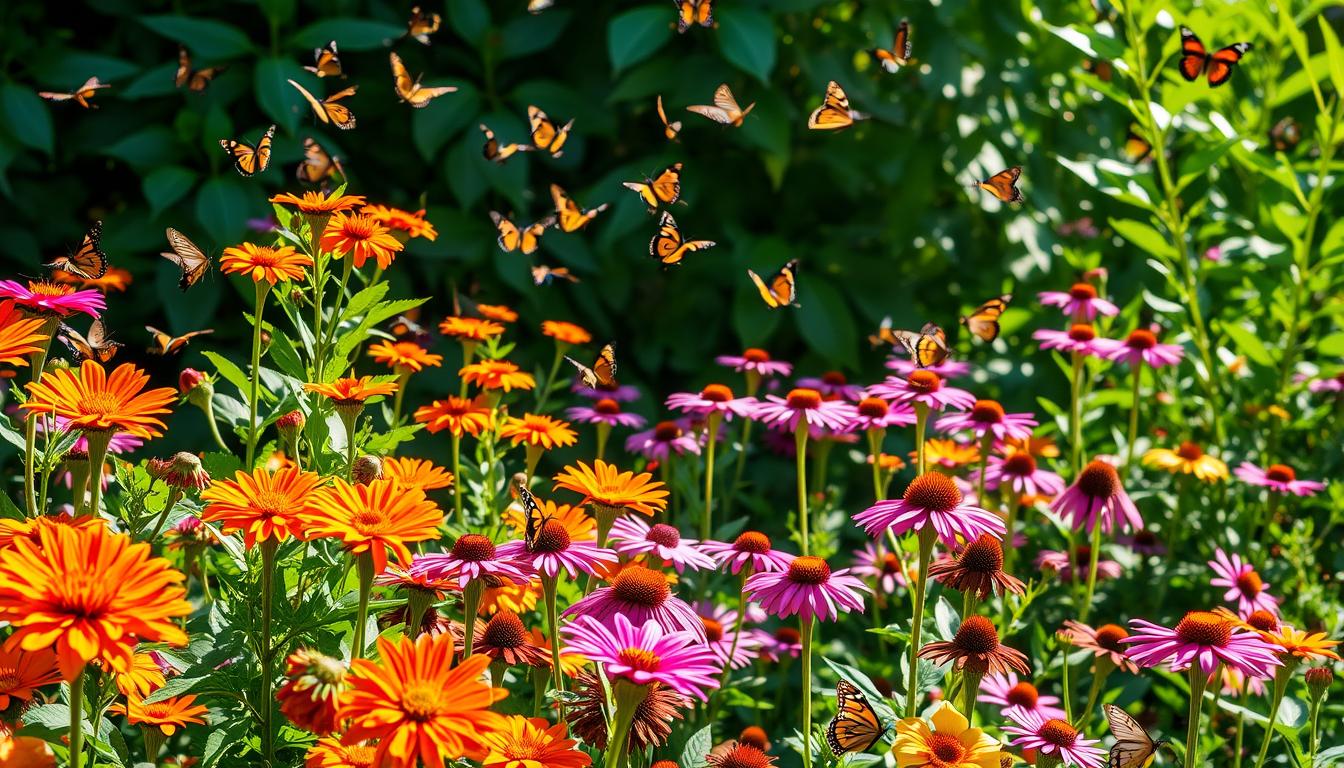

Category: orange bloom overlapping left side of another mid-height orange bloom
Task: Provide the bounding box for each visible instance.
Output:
[200,467,323,549]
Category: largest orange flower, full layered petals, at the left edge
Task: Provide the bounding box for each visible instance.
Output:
[0,526,191,681]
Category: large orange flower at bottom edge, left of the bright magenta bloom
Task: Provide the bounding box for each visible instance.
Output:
[340,633,508,768]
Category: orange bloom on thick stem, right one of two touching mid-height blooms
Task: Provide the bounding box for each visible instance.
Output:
[301,477,444,573]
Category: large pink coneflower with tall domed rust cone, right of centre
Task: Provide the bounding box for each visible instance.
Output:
[853,472,1008,546]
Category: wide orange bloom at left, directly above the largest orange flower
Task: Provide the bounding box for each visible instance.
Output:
[19,360,177,440]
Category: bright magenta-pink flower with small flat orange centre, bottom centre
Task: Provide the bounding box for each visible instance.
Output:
[560,615,719,701]
